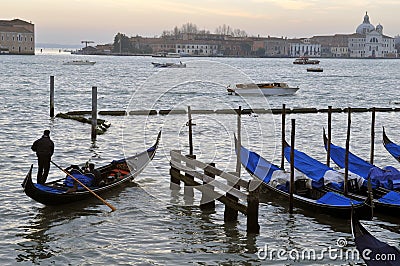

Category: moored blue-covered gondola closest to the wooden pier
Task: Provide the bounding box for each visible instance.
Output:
[236,139,370,219]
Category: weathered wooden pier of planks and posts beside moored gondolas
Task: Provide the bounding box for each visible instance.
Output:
[170,150,260,234]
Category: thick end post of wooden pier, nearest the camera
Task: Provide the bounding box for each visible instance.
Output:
[247,180,260,234]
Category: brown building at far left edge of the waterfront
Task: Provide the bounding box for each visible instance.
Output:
[0,19,35,55]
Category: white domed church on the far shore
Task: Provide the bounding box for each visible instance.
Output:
[348,12,397,58]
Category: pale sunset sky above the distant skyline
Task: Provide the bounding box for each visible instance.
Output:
[0,0,400,45]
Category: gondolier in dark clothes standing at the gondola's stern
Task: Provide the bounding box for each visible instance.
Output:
[31,130,54,184]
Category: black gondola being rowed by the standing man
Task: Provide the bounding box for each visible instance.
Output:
[22,131,161,205]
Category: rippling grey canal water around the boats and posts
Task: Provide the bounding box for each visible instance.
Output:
[0,53,400,265]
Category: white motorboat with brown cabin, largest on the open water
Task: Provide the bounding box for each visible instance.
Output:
[227,82,299,96]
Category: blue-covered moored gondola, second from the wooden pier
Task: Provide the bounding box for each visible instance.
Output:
[285,139,400,217]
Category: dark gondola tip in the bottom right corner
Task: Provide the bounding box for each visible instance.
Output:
[351,213,400,266]
